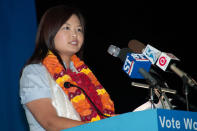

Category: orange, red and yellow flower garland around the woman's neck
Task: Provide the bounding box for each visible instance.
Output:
[43,51,114,122]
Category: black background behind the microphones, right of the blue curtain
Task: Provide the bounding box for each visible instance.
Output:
[36,0,197,113]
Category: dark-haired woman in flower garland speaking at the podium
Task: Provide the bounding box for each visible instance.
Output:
[20,5,114,131]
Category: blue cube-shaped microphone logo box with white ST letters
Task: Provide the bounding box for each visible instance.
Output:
[122,53,151,79]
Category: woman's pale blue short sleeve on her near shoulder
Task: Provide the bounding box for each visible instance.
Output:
[19,64,51,104]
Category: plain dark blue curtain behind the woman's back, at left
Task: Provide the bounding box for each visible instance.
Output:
[0,0,37,131]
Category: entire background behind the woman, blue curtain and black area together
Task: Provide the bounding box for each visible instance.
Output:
[0,0,197,131]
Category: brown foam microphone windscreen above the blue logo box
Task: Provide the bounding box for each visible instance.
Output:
[128,40,146,54]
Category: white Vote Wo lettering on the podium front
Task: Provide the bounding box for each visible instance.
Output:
[159,116,197,130]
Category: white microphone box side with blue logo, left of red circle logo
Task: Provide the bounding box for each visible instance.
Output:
[143,44,161,64]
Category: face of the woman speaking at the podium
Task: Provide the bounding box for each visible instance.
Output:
[54,14,84,57]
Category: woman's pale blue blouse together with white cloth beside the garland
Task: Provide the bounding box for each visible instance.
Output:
[20,62,81,131]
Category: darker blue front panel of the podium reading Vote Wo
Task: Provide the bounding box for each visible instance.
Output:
[157,109,197,131]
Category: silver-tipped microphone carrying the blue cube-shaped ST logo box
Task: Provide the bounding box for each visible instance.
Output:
[107,40,155,79]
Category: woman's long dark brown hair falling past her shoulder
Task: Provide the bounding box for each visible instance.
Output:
[25,5,85,69]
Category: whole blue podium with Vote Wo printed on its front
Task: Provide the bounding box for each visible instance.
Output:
[62,109,197,131]
